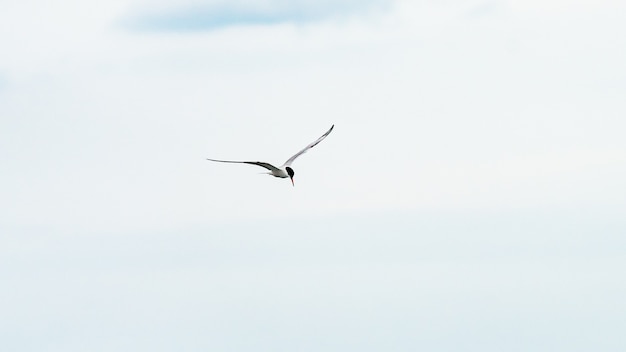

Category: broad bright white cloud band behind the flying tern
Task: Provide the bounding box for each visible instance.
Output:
[1,2,626,229]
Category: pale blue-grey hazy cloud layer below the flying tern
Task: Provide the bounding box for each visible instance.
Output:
[0,212,626,352]
